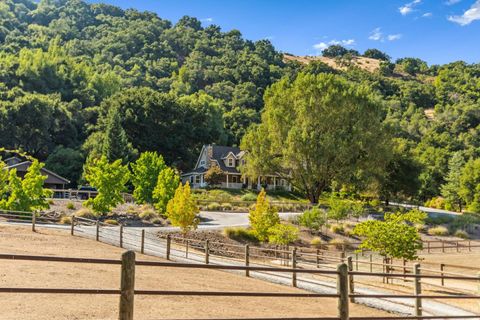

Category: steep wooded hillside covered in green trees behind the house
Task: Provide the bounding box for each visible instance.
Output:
[0,0,480,207]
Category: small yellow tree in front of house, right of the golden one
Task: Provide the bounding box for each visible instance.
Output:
[248,189,280,241]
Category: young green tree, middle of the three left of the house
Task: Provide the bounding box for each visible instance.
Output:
[130,151,167,202]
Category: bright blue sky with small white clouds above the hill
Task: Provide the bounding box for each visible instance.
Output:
[90,0,480,64]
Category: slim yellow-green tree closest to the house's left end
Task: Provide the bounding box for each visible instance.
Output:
[153,167,180,213]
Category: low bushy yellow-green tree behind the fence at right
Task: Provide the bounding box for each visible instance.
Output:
[353,212,425,260]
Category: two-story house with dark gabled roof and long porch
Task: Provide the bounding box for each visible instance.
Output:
[182,145,291,190]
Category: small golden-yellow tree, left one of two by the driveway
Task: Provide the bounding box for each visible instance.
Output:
[167,182,200,235]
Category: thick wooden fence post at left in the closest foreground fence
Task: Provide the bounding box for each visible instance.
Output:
[119,251,135,320]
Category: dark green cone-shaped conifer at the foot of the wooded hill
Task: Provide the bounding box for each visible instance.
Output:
[101,108,136,163]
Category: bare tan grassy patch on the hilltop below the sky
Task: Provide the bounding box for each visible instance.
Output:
[283,54,381,72]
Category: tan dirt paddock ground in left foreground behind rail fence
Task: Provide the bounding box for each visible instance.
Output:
[0,225,387,320]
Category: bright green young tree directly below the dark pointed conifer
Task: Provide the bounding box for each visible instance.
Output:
[83,156,130,214]
